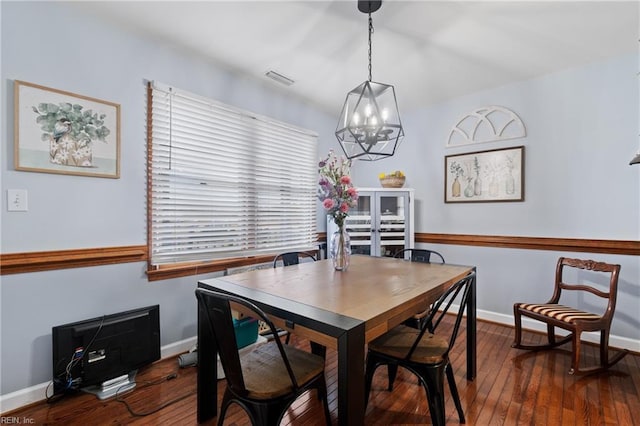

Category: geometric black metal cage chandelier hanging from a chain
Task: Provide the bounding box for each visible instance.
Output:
[336,0,404,161]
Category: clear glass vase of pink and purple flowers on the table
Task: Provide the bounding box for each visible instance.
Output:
[318,150,358,271]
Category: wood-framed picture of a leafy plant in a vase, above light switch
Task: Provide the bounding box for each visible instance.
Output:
[14,80,120,178]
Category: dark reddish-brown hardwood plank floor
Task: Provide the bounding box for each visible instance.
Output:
[3,321,640,426]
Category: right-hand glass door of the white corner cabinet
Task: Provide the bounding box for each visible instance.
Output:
[375,193,409,257]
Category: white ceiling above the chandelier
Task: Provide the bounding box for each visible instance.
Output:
[73,0,640,115]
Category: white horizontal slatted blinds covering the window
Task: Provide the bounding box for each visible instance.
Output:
[149,82,317,266]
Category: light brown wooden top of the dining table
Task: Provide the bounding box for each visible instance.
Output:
[212,255,473,341]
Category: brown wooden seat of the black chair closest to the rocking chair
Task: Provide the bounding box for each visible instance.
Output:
[369,325,449,364]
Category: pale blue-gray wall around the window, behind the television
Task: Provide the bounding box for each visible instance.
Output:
[0,1,335,395]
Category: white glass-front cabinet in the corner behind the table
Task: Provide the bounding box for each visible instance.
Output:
[327,188,414,257]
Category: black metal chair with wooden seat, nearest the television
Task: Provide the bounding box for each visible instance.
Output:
[196,288,331,425]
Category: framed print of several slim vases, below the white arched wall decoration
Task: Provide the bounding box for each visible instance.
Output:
[444,146,524,203]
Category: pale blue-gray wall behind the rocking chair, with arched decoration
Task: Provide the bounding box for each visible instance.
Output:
[354,55,640,342]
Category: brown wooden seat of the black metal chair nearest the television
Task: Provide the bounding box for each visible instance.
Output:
[240,341,324,399]
